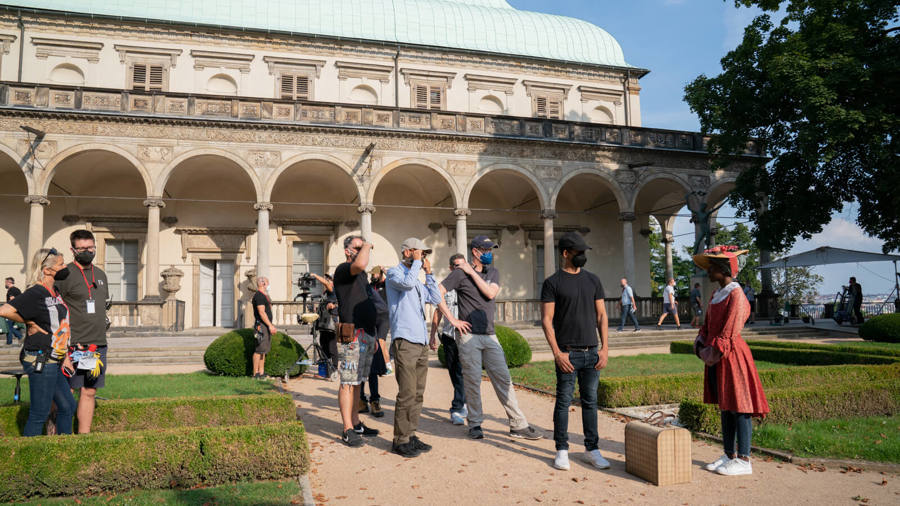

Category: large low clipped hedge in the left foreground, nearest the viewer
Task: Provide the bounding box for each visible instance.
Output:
[0,421,309,502]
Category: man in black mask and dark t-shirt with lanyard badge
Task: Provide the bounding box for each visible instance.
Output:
[56,230,109,434]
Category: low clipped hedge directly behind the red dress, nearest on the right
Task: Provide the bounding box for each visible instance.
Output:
[678,380,900,434]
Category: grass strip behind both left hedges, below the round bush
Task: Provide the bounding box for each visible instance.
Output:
[0,372,275,405]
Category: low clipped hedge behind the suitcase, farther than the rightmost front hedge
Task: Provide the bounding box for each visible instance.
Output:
[597,360,900,408]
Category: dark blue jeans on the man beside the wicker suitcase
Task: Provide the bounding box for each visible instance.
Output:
[553,346,600,451]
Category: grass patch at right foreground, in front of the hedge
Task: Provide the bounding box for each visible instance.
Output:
[753,415,900,463]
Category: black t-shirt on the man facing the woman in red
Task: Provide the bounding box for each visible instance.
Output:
[541,269,604,347]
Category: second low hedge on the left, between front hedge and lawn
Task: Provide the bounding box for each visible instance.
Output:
[0,393,297,437]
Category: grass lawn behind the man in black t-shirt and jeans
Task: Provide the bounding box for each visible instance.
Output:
[509,353,795,392]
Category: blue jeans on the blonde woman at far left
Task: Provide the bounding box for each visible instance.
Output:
[22,355,75,437]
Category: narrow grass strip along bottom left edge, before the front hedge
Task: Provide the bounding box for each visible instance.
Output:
[6,480,302,506]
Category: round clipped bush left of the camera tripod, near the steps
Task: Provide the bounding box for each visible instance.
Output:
[203,329,306,376]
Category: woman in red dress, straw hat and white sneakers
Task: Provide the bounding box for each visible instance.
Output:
[694,246,769,476]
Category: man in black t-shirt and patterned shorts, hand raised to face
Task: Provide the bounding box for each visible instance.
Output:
[334,236,378,447]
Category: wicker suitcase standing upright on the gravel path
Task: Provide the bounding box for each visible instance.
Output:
[625,421,691,485]
